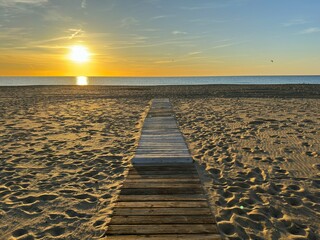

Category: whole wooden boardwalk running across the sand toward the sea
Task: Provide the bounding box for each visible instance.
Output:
[106,99,221,240]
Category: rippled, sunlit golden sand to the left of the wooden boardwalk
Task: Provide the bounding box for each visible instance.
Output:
[0,89,148,240]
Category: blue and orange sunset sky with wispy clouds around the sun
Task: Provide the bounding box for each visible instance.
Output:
[0,0,320,76]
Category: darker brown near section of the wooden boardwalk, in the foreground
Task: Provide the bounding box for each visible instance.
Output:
[105,164,221,240]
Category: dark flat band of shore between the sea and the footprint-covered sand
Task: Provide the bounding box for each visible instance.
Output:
[0,84,320,99]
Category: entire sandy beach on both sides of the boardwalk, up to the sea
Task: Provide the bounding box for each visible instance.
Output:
[0,85,320,240]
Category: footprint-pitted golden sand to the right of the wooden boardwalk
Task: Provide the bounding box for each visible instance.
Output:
[174,98,320,239]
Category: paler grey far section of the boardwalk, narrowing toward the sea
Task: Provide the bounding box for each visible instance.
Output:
[133,99,192,164]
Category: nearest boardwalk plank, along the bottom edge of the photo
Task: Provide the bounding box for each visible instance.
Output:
[106,234,221,240]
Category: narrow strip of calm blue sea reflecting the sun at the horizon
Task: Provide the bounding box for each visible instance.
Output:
[0,76,320,86]
